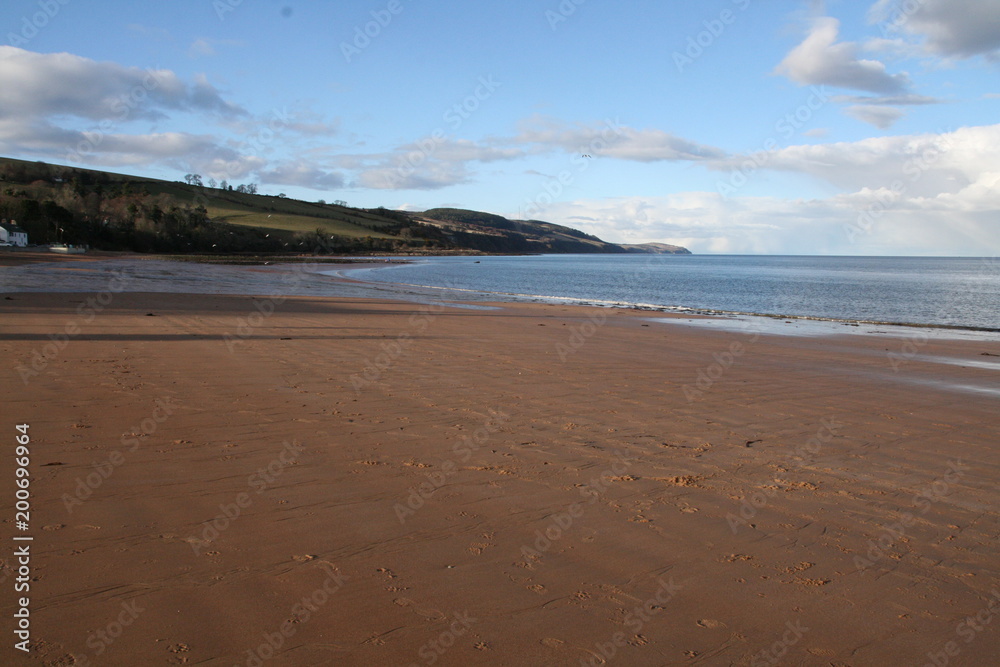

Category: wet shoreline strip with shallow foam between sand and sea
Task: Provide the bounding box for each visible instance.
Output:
[0,252,1000,341]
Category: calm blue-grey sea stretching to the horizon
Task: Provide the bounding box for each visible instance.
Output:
[352,255,1000,331]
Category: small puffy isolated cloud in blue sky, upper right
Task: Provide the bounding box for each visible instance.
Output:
[775,17,910,95]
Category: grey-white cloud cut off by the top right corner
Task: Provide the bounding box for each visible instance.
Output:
[869,0,1000,59]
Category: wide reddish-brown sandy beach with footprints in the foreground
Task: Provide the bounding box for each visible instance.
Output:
[0,258,1000,667]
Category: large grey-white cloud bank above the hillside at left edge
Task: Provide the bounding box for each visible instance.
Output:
[0,47,304,179]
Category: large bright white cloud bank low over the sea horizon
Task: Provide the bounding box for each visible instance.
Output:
[533,125,1000,255]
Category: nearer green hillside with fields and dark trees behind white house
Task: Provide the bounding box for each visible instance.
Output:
[0,158,447,253]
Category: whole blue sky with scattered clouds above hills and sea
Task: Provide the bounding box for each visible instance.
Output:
[0,0,1000,255]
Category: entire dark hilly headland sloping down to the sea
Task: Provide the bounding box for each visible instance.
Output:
[0,158,687,254]
